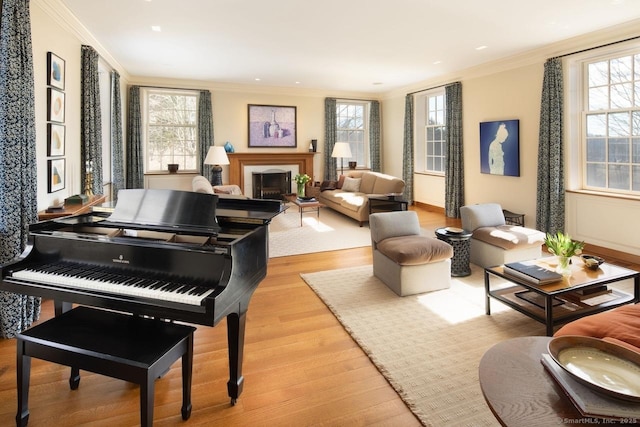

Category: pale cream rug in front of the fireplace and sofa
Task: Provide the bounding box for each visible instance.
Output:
[269,204,371,258]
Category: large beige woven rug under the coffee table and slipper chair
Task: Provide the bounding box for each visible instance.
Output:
[301,265,545,427]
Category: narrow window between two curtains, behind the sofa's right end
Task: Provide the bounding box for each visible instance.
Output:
[415,89,446,175]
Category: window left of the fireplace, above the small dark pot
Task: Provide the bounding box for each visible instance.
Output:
[143,89,199,172]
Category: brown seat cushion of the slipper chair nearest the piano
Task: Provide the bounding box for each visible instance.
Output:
[376,235,453,265]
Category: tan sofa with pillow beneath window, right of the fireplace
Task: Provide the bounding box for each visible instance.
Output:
[317,171,405,227]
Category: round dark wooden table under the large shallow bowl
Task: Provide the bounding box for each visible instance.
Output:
[478,337,607,427]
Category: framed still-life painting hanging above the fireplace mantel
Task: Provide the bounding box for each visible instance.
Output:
[248,104,297,148]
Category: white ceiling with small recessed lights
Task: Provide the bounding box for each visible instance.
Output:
[61,0,640,93]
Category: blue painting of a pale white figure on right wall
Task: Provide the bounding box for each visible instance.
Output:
[480,120,520,176]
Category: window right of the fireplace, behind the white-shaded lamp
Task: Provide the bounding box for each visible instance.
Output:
[336,101,370,168]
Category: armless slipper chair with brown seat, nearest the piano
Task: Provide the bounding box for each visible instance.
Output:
[369,211,453,296]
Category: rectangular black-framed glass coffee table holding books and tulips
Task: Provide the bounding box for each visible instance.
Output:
[484,257,640,336]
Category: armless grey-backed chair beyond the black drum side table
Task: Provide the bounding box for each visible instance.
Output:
[460,203,545,267]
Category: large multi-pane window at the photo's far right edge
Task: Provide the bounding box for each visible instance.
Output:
[581,47,640,195]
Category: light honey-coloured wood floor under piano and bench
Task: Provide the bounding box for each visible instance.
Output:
[0,208,636,427]
